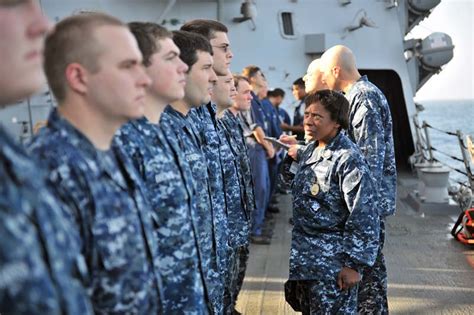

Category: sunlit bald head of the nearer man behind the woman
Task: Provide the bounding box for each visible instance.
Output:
[320,45,360,90]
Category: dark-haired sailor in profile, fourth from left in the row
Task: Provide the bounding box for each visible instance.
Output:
[160,31,226,314]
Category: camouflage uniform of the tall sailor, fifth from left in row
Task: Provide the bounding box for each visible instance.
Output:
[186,103,232,279]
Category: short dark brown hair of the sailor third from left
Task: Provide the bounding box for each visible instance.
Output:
[128,22,173,67]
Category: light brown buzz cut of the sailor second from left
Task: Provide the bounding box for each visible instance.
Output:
[44,12,127,103]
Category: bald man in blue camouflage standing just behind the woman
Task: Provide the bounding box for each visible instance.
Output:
[321,45,397,314]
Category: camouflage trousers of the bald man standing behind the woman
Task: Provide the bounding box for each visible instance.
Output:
[357,220,388,315]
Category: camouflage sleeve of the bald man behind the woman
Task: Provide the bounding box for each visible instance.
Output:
[352,95,385,183]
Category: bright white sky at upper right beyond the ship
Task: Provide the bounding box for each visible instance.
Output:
[407,0,474,101]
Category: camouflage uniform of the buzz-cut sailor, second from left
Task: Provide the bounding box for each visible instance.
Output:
[30,110,162,314]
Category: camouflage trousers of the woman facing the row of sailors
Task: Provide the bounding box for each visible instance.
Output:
[297,279,357,315]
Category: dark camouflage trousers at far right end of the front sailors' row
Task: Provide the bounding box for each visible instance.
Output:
[224,246,249,314]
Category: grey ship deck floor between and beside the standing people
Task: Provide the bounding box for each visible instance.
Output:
[236,174,474,315]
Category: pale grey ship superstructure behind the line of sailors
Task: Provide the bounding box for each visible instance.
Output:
[0,0,453,167]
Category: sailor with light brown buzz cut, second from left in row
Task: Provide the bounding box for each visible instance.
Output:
[30,13,162,314]
